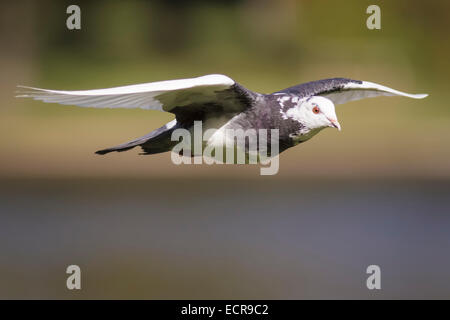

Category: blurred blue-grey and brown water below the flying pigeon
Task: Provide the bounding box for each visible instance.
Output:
[0,178,450,299]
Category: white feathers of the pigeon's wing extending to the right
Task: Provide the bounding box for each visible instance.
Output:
[321,81,428,104]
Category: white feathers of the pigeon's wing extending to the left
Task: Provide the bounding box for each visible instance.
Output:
[17,74,235,111]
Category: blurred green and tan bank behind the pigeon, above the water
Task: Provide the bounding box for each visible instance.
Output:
[0,0,450,176]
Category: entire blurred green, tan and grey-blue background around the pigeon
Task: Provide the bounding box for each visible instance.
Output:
[0,0,450,299]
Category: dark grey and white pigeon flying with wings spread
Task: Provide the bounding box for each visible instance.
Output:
[18,74,427,154]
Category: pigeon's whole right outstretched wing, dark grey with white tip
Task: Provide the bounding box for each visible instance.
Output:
[275,78,428,104]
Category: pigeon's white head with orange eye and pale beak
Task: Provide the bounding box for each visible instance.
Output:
[302,96,341,131]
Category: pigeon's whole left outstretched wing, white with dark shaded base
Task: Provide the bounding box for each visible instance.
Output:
[17,74,254,120]
